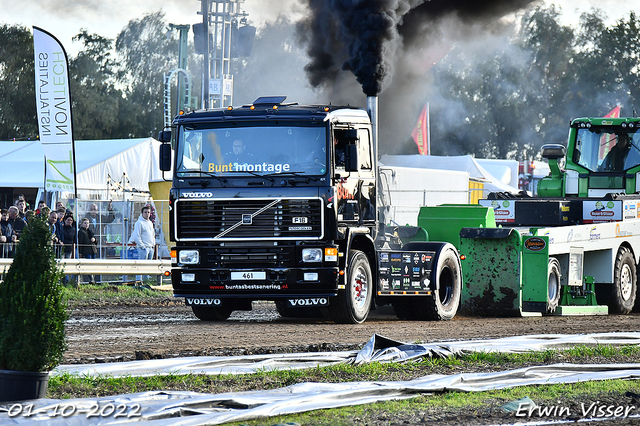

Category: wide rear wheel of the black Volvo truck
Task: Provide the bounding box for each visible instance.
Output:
[424,244,462,321]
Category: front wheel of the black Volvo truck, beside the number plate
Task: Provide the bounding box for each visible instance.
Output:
[329,250,374,324]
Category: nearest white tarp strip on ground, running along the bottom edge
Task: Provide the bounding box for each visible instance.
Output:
[0,364,640,426]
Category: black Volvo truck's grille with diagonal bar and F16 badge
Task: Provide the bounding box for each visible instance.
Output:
[175,198,323,241]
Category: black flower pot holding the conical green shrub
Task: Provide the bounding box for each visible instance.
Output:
[0,370,49,403]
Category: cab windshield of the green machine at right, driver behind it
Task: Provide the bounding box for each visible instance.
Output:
[573,127,640,172]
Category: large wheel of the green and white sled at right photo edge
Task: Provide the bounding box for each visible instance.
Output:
[608,247,637,314]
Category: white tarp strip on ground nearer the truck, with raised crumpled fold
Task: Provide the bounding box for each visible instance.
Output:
[52,332,640,377]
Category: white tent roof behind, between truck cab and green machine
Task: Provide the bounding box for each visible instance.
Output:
[380,154,520,198]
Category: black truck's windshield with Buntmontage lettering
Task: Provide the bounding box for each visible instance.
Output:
[176,122,327,176]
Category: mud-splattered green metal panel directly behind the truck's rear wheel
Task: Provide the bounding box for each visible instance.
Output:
[460,228,549,316]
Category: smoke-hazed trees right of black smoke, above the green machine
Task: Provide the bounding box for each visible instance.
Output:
[425,5,640,160]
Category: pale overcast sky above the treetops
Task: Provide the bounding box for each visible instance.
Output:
[0,0,640,56]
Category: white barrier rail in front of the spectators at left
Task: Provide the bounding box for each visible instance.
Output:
[0,259,171,275]
